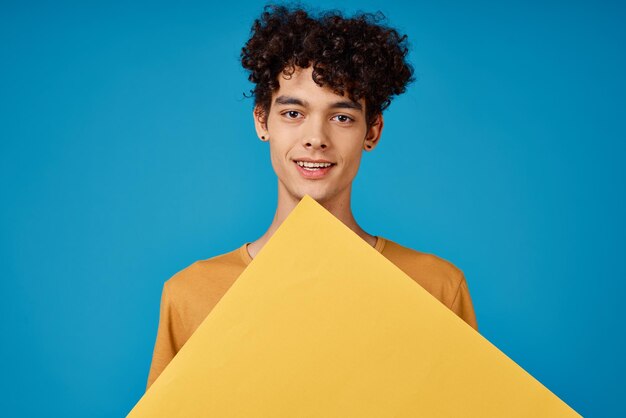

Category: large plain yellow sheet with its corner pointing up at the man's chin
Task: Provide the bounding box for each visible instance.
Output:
[129,196,579,418]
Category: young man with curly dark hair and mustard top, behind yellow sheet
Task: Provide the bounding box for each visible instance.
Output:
[148,6,477,387]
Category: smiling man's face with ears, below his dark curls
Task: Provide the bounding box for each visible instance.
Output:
[255,67,382,207]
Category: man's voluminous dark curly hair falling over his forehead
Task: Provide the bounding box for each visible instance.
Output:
[241,5,414,125]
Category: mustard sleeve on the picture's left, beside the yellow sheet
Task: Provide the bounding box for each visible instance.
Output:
[146,283,182,390]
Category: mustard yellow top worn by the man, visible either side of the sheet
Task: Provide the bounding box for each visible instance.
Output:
[147,236,478,387]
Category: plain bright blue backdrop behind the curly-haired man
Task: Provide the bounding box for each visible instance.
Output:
[0,1,626,417]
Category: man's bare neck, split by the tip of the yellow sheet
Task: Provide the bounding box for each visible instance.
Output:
[248,181,376,258]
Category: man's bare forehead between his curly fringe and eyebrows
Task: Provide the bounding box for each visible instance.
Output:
[272,66,365,106]
